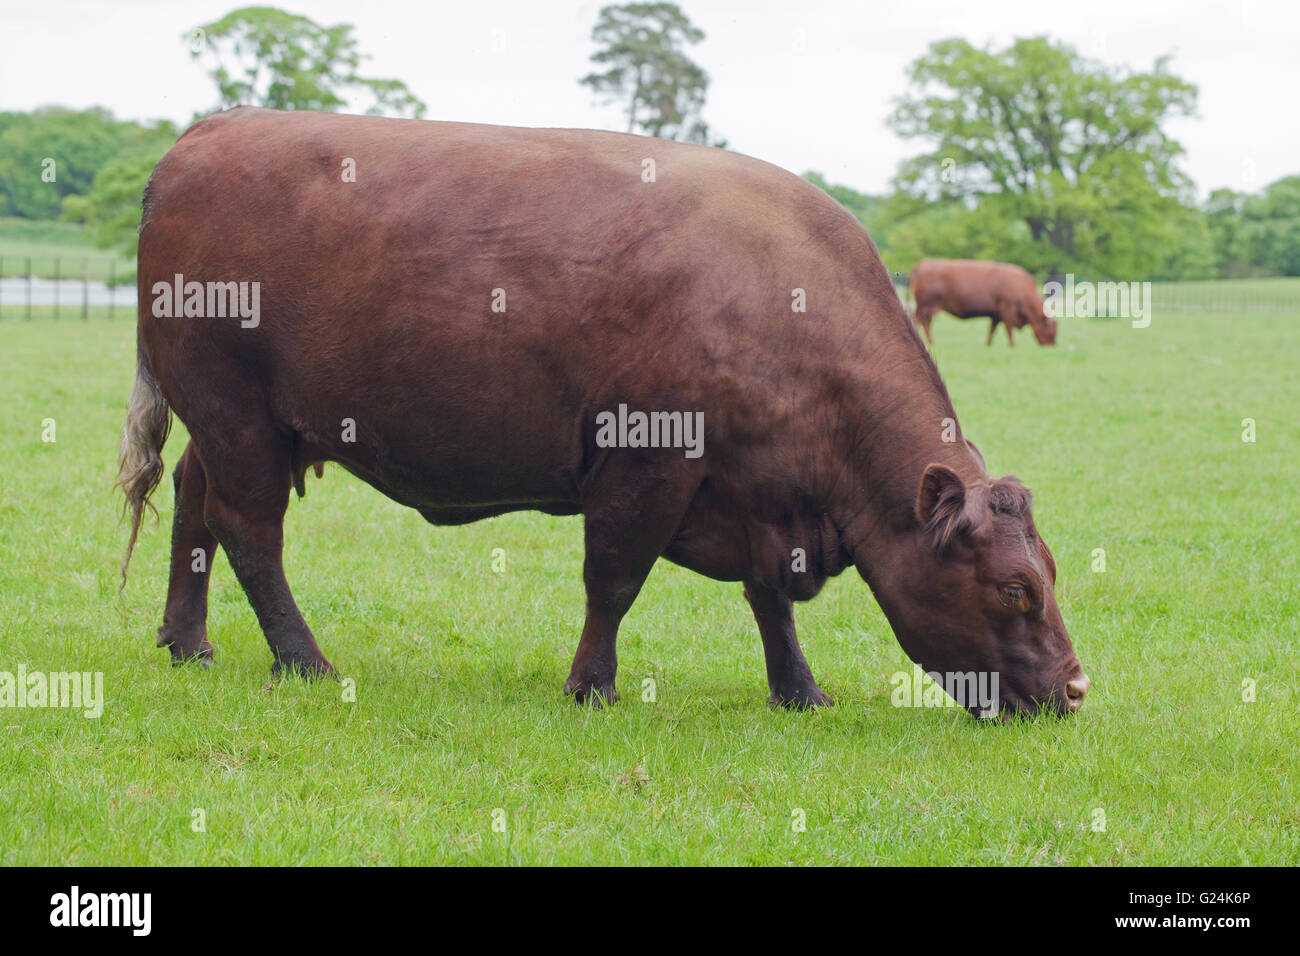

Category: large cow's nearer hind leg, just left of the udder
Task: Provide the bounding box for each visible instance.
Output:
[196,416,334,675]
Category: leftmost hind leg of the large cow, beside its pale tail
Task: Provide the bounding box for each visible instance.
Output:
[157,441,217,665]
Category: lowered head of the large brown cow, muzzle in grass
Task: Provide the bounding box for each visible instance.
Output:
[872,464,1089,717]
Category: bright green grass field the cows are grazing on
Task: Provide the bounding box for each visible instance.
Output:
[0,300,1300,865]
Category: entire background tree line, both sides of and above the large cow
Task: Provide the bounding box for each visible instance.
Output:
[0,3,1300,280]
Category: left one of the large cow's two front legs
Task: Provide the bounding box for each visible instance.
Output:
[564,460,694,705]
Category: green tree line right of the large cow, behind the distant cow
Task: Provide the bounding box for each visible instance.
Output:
[807,36,1300,280]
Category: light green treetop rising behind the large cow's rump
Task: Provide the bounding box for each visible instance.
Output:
[186,7,425,118]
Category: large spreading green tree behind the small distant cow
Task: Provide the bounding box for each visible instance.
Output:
[889,36,1204,277]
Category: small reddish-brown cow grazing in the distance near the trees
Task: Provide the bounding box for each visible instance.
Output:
[911,259,1056,345]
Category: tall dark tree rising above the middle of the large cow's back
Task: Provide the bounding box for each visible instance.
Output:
[579,3,727,146]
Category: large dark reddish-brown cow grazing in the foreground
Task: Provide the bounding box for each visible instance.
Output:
[120,109,1088,715]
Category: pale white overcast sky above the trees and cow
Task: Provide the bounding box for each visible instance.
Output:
[0,0,1300,195]
